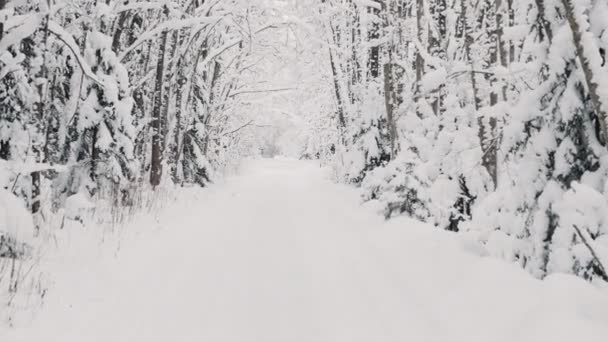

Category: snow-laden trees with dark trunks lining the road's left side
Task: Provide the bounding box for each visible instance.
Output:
[0,0,283,257]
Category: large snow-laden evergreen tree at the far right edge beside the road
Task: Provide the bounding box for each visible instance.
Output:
[466,1,606,278]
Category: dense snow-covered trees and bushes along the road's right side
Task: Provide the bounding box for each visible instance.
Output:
[308,0,608,280]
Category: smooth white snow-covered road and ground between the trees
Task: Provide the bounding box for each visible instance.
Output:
[0,160,608,342]
